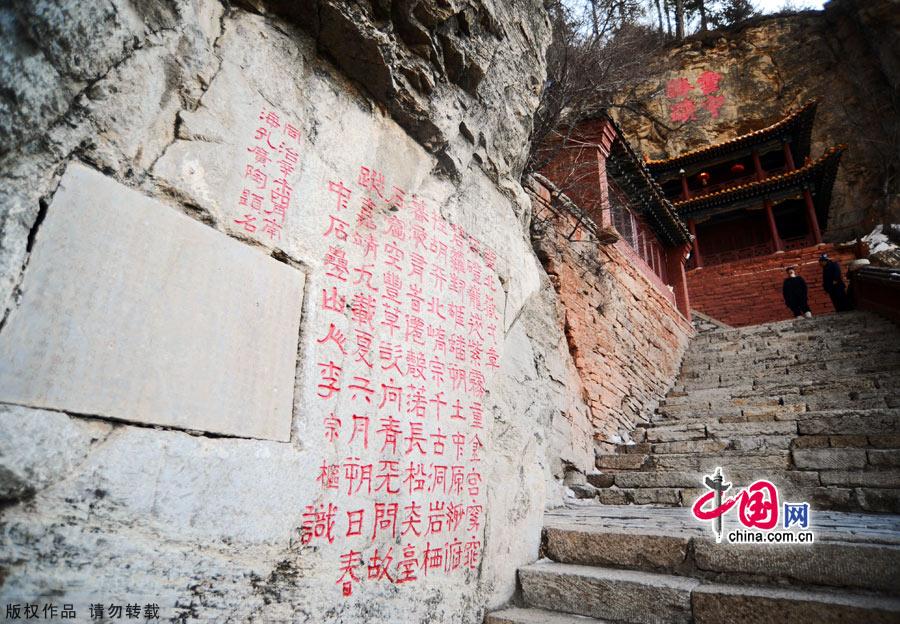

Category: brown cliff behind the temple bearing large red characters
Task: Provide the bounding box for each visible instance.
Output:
[616,0,900,241]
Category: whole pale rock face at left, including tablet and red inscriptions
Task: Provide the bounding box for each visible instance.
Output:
[0,0,604,624]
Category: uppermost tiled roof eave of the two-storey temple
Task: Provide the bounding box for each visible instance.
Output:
[645,100,818,181]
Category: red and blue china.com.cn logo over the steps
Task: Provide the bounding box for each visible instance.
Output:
[691,468,814,544]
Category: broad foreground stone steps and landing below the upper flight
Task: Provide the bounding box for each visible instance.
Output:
[485,503,900,624]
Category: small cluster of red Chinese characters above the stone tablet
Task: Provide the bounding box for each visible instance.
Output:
[233,108,300,241]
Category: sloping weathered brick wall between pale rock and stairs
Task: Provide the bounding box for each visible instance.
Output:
[532,183,693,442]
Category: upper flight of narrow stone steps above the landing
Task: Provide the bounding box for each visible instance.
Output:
[592,312,900,513]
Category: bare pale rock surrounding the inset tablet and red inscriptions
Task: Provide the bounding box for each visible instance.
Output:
[0,0,593,624]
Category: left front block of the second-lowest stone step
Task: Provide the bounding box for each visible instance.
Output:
[519,561,700,624]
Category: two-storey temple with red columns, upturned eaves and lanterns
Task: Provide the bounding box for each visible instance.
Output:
[645,101,844,268]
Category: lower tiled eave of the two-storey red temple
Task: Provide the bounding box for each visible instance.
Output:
[674,145,846,220]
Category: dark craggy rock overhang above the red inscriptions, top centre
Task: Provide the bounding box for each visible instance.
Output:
[232,0,550,181]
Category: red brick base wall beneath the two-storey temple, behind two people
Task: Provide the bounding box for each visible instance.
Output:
[687,245,856,327]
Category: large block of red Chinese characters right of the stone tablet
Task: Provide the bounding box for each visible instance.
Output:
[299,166,503,596]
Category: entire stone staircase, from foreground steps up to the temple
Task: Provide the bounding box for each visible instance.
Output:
[485,313,900,624]
